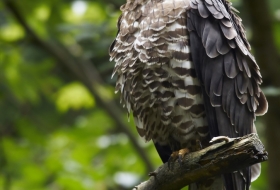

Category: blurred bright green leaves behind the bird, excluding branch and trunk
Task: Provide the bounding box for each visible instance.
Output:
[0,0,280,190]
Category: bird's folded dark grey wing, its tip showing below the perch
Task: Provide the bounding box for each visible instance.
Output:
[187,0,267,190]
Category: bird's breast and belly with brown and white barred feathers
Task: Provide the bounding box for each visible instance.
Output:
[111,0,208,147]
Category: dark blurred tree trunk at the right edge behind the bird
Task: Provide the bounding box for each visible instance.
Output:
[243,0,280,190]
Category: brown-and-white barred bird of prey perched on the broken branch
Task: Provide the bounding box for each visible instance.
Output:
[109,0,268,190]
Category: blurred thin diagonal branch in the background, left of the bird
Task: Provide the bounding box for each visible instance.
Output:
[4,0,154,171]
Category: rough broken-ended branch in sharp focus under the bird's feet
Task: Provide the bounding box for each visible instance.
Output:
[134,133,268,190]
